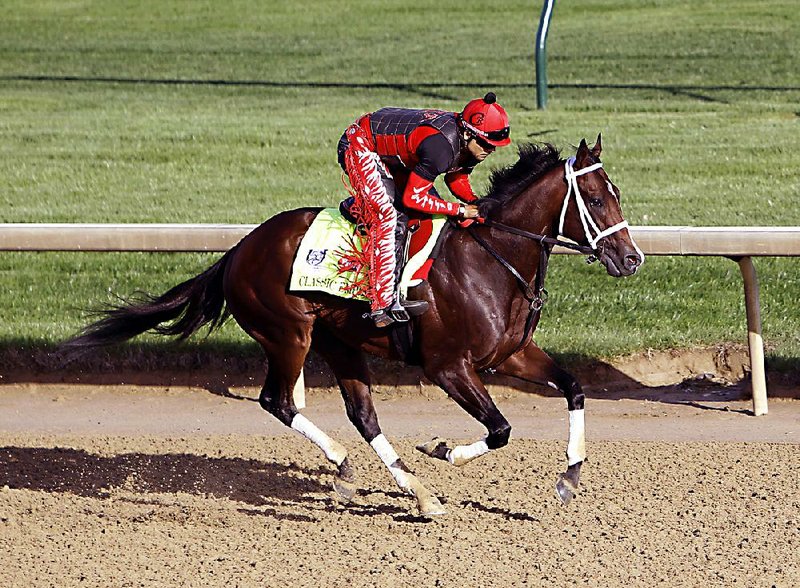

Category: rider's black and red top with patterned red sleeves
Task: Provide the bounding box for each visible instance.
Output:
[357,107,477,215]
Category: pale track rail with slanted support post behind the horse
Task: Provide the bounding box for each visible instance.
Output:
[0,223,800,416]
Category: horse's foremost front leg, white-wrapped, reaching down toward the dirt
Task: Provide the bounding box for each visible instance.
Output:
[495,341,586,504]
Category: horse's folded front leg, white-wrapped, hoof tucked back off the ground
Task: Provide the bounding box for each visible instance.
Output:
[417,362,511,466]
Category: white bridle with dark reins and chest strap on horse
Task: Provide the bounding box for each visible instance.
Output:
[467,157,628,358]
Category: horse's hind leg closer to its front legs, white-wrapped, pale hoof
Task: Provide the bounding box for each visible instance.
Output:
[314,329,445,516]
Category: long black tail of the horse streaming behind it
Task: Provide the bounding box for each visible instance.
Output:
[59,250,233,361]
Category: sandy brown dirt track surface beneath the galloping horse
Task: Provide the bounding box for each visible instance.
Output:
[0,376,800,588]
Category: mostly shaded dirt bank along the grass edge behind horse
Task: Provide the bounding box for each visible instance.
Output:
[0,341,800,409]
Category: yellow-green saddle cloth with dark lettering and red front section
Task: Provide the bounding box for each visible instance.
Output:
[289,208,446,300]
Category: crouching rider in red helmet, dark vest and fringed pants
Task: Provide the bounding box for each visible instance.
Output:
[338,92,511,327]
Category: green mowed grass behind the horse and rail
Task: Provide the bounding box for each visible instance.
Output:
[0,0,800,366]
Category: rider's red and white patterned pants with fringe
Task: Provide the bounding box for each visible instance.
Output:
[344,124,397,311]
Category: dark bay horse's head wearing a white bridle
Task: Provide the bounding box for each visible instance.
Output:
[558,135,644,277]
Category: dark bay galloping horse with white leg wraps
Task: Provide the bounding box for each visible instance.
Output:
[62,136,644,516]
